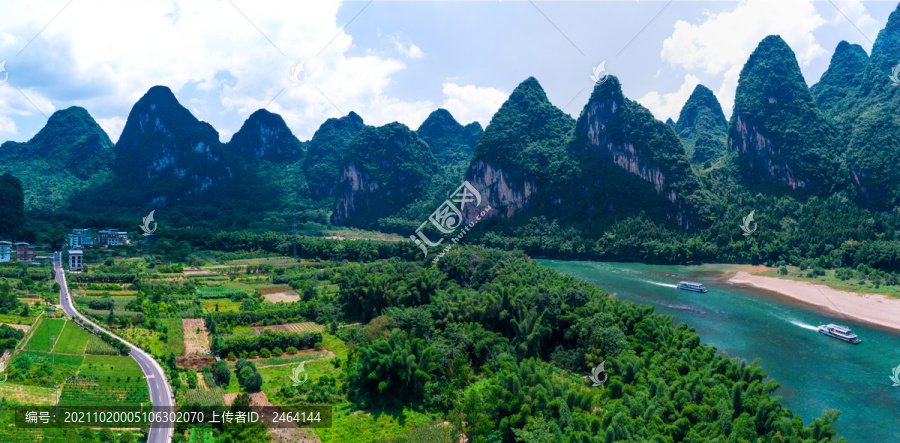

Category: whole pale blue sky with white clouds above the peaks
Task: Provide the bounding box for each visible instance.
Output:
[0,0,897,142]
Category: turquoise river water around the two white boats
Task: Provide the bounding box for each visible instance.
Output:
[538,260,900,443]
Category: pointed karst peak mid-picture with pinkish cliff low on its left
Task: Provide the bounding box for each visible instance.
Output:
[464,77,574,221]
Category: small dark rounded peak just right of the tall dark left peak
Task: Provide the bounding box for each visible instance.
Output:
[227,109,303,163]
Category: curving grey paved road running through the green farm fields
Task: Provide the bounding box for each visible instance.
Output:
[53,252,175,443]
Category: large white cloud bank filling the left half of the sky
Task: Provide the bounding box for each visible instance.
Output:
[0,0,432,138]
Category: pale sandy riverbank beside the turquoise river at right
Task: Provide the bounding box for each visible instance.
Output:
[726,271,900,331]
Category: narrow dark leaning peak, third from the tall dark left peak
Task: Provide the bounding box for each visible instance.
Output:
[303,111,366,200]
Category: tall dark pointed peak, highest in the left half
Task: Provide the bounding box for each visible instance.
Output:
[114,86,240,203]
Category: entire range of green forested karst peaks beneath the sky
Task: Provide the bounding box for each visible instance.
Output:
[8,2,900,278]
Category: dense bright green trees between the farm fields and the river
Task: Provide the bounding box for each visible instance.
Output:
[156,239,839,442]
